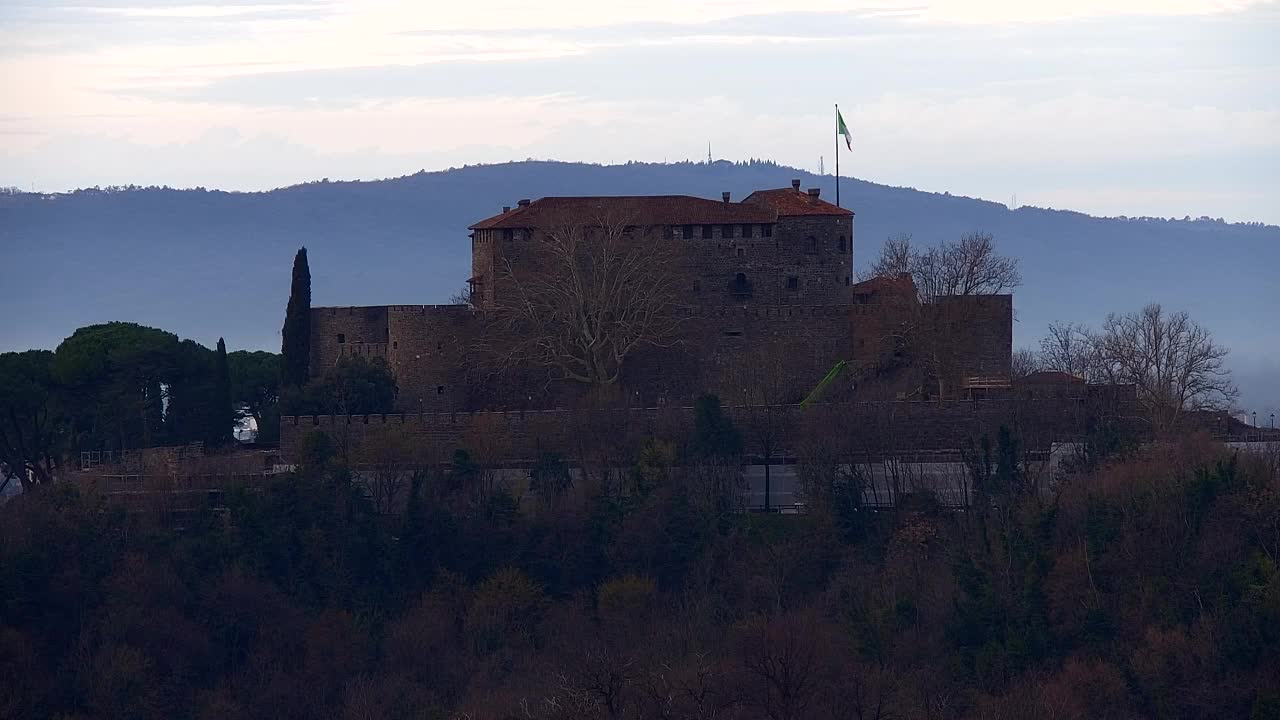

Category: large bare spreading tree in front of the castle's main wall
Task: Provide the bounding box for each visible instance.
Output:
[484,207,686,386]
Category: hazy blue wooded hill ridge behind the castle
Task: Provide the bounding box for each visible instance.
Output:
[0,161,1280,418]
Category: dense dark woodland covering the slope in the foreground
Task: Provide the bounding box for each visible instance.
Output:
[0,417,1280,720]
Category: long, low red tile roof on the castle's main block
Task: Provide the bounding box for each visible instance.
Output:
[470,195,778,231]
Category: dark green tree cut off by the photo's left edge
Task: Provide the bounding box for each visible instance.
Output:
[0,350,68,491]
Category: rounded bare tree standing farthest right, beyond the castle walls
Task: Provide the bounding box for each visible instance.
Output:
[1096,302,1236,429]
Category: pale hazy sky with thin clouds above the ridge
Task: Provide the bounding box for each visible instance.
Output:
[0,0,1280,223]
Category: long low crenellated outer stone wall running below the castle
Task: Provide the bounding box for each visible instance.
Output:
[280,400,1121,464]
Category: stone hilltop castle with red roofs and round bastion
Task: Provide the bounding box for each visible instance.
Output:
[311,181,1012,413]
